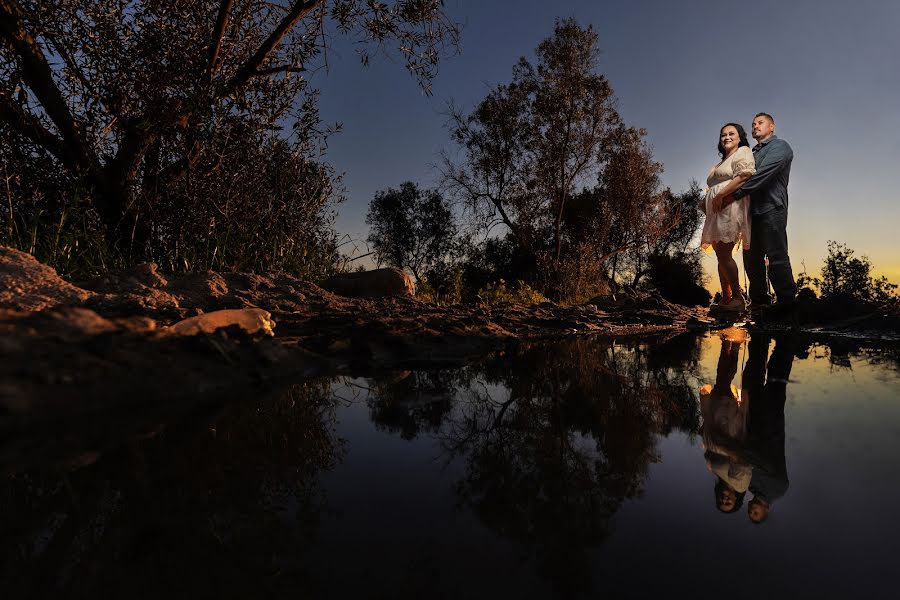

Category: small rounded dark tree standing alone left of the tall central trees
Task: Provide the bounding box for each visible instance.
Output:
[366,181,456,280]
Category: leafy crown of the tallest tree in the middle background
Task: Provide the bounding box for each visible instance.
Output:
[445,19,619,260]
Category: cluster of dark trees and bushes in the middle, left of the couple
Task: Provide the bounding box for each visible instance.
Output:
[367,20,709,304]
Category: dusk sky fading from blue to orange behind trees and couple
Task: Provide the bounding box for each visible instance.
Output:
[315,0,900,289]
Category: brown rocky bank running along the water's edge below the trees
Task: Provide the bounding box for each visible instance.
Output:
[0,247,900,469]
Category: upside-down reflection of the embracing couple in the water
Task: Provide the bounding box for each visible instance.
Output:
[700,329,798,524]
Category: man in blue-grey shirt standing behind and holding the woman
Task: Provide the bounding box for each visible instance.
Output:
[722,113,797,315]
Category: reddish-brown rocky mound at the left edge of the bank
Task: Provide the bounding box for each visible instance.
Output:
[0,246,93,311]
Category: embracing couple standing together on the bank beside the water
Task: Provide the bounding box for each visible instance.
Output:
[700,113,797,318]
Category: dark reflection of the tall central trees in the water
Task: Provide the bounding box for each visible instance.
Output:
[441,339,699,591]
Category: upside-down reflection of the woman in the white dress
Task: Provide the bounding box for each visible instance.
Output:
[700,329,752,513]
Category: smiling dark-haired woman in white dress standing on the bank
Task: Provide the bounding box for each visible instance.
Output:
[700,123,756,313]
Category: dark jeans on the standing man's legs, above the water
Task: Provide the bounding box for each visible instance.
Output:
[744,208,797,306]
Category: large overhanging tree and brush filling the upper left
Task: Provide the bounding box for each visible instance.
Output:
[0,0,458,271]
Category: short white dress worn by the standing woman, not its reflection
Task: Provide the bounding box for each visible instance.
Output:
[700,146,756,252]
